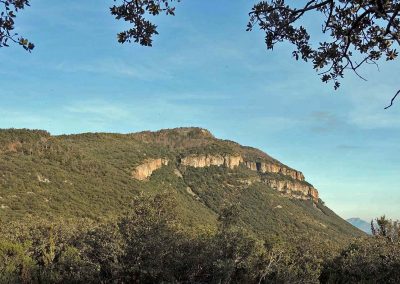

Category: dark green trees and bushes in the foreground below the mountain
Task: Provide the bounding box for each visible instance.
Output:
[0,192,400,283]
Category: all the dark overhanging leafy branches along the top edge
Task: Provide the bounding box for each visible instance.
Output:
[0,0,400,108]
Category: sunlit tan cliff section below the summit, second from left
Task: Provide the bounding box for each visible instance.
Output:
[180,155,243,169]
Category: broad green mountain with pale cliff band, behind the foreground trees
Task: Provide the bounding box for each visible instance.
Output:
[0,128,363,243]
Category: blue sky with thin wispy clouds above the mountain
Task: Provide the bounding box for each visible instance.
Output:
[0,0,400,221]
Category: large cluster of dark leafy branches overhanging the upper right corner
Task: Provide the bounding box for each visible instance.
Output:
[248,0,400,91]
